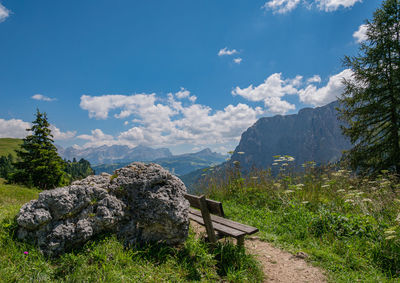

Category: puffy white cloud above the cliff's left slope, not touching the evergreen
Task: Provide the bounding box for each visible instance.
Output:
[232,73,302,114]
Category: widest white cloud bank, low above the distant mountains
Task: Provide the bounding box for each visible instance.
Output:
[78,88,263,150]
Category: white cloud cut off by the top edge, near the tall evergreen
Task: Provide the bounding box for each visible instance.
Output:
[261,0,362,14]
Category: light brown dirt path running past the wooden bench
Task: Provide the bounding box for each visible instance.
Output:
[191,221,327,283]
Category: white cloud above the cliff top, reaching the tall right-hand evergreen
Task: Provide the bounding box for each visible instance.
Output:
[299,69,353,106]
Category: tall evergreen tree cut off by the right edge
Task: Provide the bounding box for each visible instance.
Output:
[339,0,400,174]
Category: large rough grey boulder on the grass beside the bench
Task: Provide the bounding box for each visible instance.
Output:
[17,162,189,256]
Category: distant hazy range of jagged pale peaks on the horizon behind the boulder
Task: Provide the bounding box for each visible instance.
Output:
[57,145,172,165]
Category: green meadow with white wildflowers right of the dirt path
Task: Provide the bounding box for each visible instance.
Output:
[205,164,400,282]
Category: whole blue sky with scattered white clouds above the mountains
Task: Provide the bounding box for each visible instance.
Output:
[0,0,381,154]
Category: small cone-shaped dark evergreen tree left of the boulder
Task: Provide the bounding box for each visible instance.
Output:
[11,109,64,190]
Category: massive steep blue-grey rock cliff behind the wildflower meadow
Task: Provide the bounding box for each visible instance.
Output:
[231,101,351,169]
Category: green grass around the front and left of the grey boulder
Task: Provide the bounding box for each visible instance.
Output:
[0,179,263,282]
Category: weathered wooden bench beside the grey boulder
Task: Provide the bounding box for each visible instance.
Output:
[185,194,258,246]
